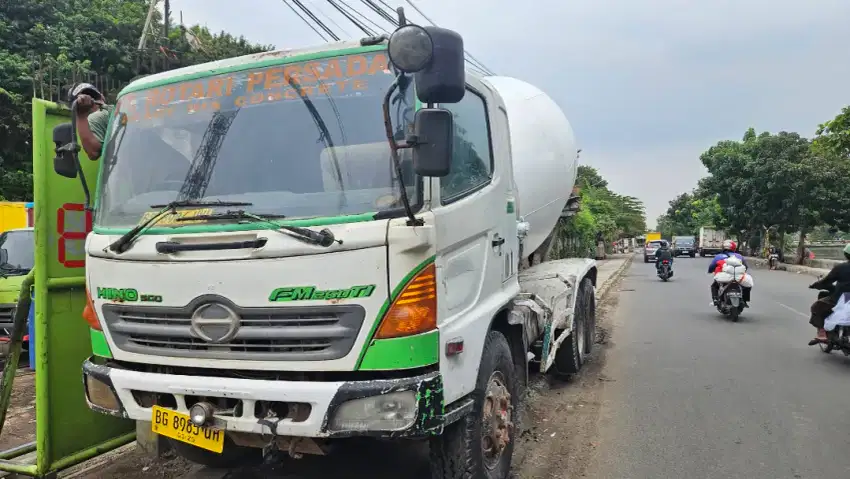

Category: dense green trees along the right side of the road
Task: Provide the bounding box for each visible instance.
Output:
[659,123,850,261]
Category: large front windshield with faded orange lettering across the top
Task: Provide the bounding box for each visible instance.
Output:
[95,52,418,231]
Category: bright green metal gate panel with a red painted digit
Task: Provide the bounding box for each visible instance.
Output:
[33,99,134,474]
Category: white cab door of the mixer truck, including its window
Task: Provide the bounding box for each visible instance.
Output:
[433,84,518,401]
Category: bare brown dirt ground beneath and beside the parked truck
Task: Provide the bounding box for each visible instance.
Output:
[0,270,619,479]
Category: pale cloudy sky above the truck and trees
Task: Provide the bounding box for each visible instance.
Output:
[166,0,850,226]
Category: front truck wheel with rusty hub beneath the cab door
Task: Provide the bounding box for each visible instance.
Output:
[430,331,519,479]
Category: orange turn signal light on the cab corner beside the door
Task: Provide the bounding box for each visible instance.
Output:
[375,263,437,339]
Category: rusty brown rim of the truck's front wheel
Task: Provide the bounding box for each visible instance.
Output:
[481,371,514,469]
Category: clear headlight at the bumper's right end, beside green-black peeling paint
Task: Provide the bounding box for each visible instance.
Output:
[328,391,416,431]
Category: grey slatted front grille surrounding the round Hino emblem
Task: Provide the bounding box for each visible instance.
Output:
[103,295,366,361]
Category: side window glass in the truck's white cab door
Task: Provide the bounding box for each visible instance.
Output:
[440,89,493,204]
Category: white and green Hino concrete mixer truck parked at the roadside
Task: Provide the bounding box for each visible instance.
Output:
[54,18,596,478]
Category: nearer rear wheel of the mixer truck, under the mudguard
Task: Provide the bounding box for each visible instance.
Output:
[554,278,596,376]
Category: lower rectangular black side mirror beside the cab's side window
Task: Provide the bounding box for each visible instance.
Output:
[413,108,454,177]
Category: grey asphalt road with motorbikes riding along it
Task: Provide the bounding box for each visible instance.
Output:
[584,258,850,479]
